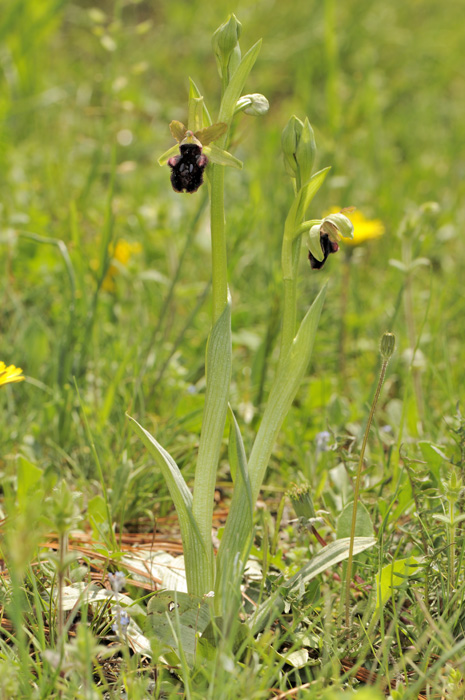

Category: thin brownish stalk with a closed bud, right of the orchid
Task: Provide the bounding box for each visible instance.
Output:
[346,333,395,627]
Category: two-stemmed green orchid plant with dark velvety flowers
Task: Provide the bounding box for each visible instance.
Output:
[130,15,362,615]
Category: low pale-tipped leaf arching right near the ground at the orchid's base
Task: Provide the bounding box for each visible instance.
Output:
[249,537,376,634]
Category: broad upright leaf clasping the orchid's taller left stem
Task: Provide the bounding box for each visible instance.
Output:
[190,303,232,584]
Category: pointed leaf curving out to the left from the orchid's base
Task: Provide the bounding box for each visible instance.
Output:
[128,415,208,593]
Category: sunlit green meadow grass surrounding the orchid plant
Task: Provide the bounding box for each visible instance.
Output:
[0,0,465,700]
